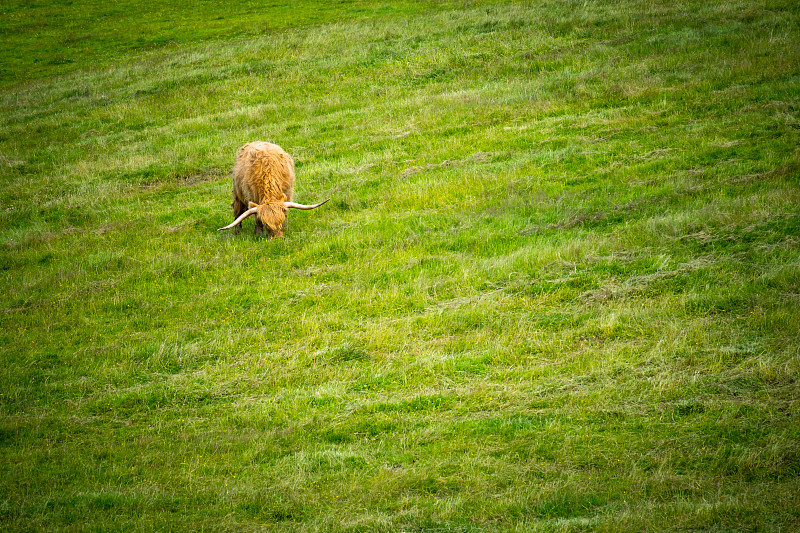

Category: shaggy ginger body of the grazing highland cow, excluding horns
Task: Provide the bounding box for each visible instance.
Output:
[232,141,294,238]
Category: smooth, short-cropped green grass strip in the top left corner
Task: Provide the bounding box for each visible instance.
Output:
[0,0,480,85]
